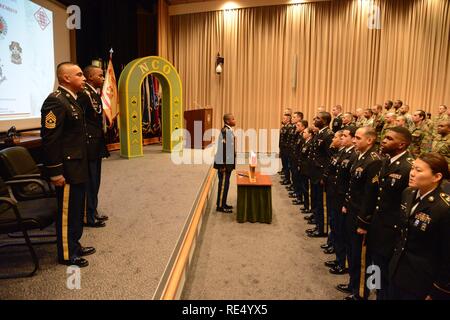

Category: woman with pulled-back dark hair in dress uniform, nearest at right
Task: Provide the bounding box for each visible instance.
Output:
[389,153,450,300]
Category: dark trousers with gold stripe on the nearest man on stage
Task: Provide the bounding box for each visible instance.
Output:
[56,184,86,262]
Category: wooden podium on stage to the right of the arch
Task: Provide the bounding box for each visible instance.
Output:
[184,109,212,149]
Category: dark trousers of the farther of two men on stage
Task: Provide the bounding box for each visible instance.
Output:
[84,158,102,224]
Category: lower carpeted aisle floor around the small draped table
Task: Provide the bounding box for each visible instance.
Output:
[182,167,348,300]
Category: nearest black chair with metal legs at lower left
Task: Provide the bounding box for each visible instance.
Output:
[0,178,57,279]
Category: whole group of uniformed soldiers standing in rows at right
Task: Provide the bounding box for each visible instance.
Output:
[280,102,450,300]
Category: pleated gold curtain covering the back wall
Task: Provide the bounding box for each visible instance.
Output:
[168,0,450,150]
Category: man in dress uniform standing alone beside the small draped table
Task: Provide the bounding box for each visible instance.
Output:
[214,113,236,213]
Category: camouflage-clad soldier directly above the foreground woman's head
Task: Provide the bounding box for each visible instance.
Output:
[410,110,432,158]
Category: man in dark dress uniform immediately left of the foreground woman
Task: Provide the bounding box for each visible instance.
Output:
[367,127,413,300]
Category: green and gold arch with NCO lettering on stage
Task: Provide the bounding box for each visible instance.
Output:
[119,56,183,159]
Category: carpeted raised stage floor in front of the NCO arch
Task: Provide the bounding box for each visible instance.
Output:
[0,146,210,300]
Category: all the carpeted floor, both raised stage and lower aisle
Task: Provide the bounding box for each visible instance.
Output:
[0,151,356,300]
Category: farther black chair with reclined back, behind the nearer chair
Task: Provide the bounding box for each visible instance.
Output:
[0,146,56,201]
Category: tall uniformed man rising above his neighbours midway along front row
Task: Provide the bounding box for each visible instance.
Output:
[306,112,334,238]
